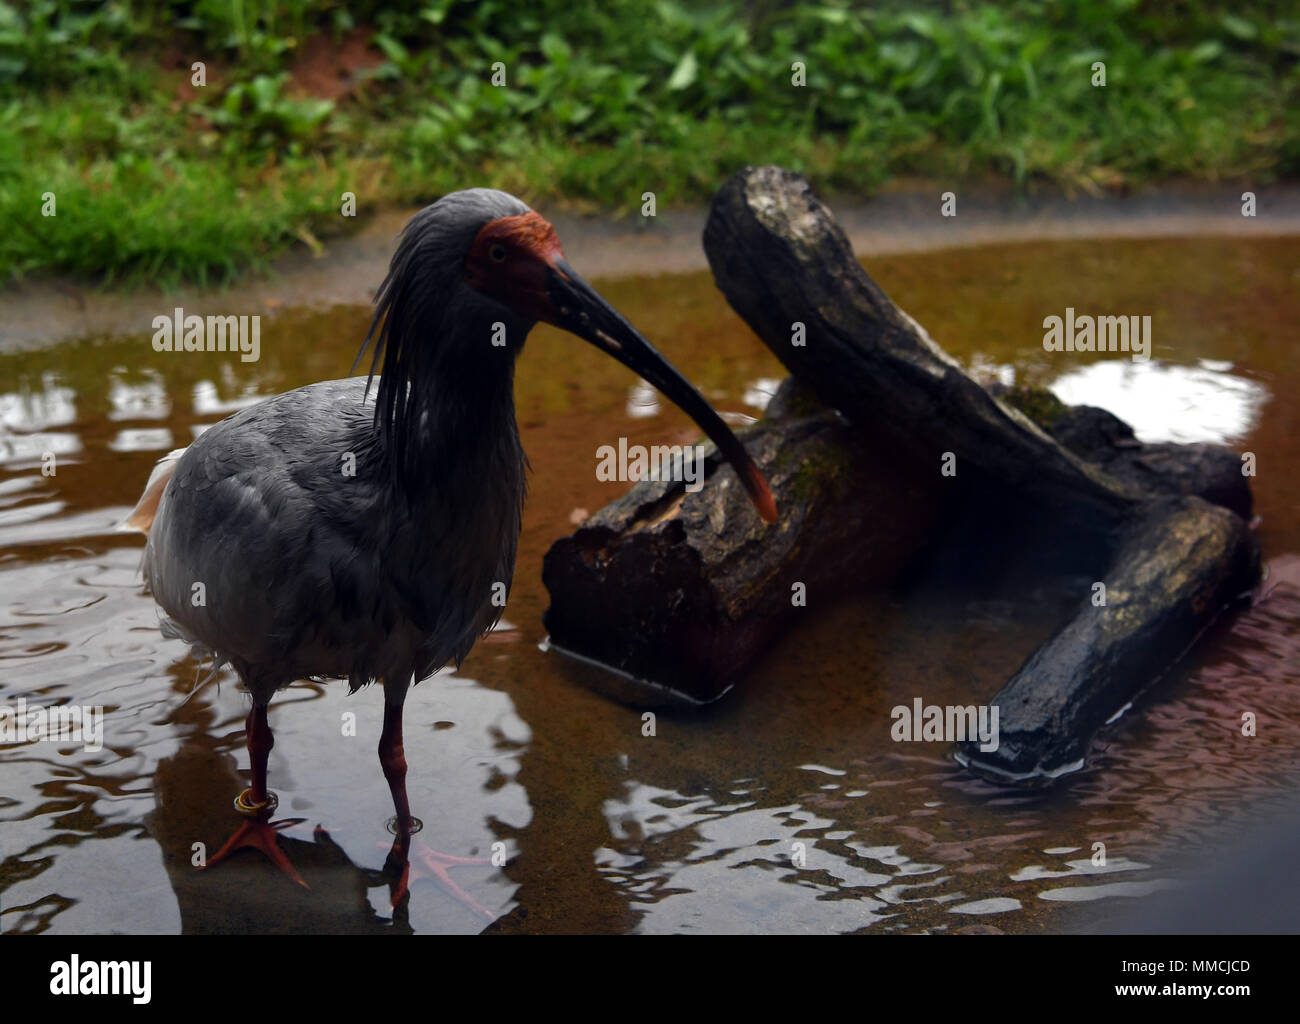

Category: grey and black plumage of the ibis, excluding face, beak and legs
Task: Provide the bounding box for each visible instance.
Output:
[143,188,532,700]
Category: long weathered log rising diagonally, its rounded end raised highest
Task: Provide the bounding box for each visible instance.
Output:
[705,168,1152,540]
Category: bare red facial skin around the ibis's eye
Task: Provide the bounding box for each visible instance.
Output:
[463,211,564,324]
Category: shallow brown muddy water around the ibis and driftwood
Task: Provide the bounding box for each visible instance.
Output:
[0,238,1300,934]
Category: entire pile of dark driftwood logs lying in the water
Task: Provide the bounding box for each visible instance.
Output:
[543,168,1258,776]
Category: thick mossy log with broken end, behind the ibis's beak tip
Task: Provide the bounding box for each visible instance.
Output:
[542,378,941,704]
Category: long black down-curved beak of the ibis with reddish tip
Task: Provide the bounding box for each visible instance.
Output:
[543,259,776,522]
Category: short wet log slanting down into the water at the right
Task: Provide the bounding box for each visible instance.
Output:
[957,498,1258,782]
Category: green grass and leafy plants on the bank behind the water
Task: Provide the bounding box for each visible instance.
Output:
[0,0,1300,283]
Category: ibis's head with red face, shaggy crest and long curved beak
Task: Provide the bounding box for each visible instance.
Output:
[363,188,776,522]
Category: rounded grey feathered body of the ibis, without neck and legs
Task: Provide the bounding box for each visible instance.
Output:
[143,369,523,685]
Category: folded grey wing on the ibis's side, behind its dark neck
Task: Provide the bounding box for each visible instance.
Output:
[142,378,392,678]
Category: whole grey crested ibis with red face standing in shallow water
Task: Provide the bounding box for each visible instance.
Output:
[130,188,776,902]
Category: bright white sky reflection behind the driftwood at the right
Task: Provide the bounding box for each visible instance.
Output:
[1049,359,1269,444]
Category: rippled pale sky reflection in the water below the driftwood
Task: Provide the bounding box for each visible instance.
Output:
[595,762,1171,933]
